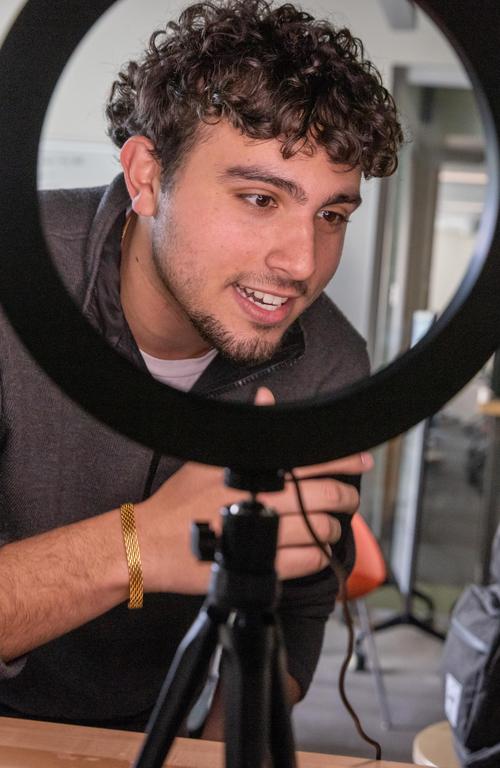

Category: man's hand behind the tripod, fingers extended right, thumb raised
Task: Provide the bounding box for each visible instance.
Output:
[135,388,373,594]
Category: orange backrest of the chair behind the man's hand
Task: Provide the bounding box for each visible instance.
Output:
[346,512,387,600]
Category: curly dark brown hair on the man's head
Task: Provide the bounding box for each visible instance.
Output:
[106,0,403,180]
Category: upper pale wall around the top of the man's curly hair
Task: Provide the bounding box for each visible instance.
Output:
[0,0,464,141]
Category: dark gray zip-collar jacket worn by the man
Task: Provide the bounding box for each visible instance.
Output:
[0,176,368,729]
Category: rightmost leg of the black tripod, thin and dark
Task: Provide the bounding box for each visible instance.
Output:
[270,624,296,768]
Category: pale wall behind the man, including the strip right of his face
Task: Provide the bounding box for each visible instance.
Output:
[0,0,468,335]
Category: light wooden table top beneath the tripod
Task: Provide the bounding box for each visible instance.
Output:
[0,717,422,768]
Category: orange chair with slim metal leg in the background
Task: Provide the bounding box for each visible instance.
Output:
[346,512,391,728]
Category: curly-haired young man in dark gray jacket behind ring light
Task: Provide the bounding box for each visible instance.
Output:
[0,0,401,729]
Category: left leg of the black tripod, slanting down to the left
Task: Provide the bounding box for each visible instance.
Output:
[134,608,225,768]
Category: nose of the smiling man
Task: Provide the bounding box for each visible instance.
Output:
[266,221,316,281]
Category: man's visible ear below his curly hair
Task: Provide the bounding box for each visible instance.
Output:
[120,136,161,216]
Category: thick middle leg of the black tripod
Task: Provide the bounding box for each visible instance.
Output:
[221,611,273,768]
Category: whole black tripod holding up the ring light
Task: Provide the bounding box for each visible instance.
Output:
[134,470,295,768]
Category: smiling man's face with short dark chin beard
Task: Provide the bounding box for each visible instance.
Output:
[152,123,360,362]
